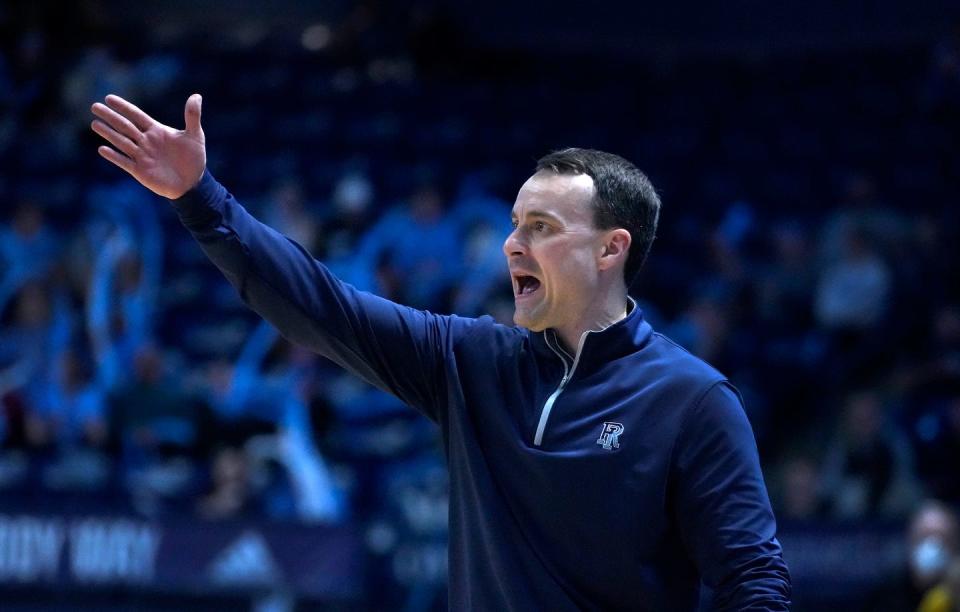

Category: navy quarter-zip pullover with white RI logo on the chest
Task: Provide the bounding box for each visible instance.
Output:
[173,172,790,612]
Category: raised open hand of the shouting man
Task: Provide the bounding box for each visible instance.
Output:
[90,94,207,199]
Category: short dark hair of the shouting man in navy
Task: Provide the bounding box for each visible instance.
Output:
[536,148,660,289]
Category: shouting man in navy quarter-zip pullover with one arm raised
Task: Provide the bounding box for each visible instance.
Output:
[92,94,790,612]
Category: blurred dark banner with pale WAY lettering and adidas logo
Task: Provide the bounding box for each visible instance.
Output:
[0,514,363,600]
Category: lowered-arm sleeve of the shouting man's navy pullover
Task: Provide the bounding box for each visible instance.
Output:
[675,382,791,610]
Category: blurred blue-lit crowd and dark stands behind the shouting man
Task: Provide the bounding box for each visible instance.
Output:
[0,0,960,611]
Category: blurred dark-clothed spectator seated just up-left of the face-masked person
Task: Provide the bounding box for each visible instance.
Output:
[821,391,917,519]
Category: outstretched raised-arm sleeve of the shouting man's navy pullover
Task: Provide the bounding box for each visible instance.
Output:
[172,171,473,421]
